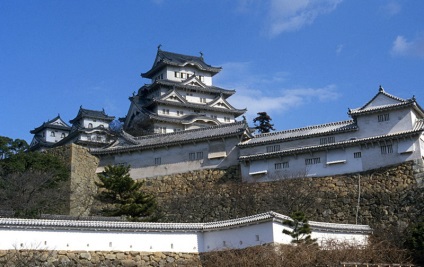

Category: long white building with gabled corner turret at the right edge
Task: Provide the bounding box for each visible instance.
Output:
[238,88,424,182]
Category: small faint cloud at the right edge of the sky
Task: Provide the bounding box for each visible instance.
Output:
[390,34,424,59]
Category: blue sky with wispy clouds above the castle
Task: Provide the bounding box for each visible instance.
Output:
[0,0,424,142]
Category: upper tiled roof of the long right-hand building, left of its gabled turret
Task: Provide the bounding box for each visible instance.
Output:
[239,120,358,147]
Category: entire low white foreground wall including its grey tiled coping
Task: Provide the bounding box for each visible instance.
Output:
[0,212,372,253]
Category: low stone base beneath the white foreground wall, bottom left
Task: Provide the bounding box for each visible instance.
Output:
[0,250,202,267]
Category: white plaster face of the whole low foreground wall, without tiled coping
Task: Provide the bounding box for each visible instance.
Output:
[0,220,367,253]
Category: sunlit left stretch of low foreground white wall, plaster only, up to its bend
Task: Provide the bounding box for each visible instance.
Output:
[0,229,203,252]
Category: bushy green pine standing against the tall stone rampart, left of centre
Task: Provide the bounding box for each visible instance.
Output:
[96,165,157,221]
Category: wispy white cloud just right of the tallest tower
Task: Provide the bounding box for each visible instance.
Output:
[214,62,340,121]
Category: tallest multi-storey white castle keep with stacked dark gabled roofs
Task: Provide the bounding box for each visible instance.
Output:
[124,48,246,136]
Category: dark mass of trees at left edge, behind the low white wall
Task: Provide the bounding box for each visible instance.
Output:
[0,136,69,218]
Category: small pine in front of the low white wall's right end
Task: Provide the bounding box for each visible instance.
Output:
[283,211,316,244]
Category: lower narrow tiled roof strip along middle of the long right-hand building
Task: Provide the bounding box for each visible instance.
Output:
[239,123,424,161]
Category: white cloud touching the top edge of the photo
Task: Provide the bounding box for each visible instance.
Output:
[267,0,342,37]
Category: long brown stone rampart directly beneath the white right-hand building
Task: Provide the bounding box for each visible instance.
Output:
[140,161,424,228]
